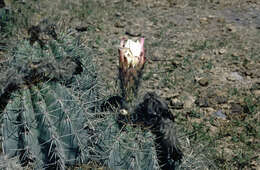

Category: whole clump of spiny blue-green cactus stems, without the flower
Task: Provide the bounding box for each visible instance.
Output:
[0,26,183,170]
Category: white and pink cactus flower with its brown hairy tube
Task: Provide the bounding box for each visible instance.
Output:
[118,38,146,102]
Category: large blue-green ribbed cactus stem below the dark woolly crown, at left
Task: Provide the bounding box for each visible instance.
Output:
[3,82,90,169]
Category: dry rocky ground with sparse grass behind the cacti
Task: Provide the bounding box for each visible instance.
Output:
[0,0,260,169]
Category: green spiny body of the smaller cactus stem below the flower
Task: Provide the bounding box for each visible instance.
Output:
[96,113,160,170]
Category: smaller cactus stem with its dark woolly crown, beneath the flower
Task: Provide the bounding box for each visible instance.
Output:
[99,92,183,170]
